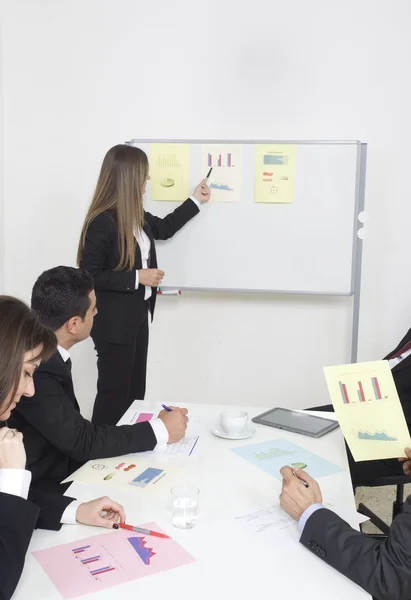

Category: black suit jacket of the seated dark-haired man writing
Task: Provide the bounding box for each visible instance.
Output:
[8,351,157,492]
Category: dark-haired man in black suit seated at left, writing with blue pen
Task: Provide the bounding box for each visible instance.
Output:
[10,267,187,492]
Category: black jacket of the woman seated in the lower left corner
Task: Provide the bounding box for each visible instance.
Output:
[0,492,73,600]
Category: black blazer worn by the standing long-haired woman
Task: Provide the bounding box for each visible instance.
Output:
[80,199,199,344]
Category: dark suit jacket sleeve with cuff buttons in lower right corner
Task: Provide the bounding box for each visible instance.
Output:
[300,497,411,600]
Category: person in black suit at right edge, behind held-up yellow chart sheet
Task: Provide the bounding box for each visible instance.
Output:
[310,338,411,486]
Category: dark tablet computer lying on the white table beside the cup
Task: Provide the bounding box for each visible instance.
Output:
[252,408,338,438]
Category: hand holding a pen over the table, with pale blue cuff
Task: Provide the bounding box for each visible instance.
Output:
[280,467,323,521]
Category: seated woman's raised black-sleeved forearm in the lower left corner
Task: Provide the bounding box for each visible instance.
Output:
[0,493,39,600]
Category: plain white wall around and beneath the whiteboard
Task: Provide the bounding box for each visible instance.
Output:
[3,0,411,418]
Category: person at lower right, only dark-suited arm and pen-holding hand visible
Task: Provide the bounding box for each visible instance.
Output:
[280,448,411,600]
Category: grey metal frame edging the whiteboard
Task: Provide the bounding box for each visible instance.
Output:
[125,138,367,363]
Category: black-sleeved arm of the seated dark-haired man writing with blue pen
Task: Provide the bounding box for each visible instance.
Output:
[17,371,157,463]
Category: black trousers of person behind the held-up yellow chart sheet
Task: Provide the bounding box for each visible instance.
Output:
[308,404,404,487]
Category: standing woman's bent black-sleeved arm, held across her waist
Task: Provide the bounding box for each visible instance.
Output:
[80,213,136,292]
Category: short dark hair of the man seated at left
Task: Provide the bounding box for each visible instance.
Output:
[31,267,94,331]
